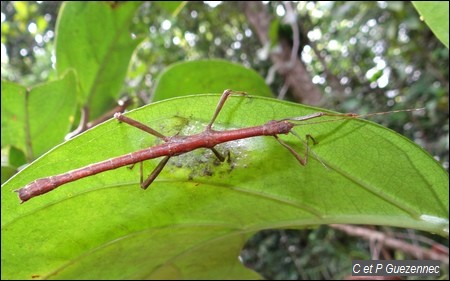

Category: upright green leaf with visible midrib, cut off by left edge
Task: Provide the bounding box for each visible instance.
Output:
[1,72,77,161]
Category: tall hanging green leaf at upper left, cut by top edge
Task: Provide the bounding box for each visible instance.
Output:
[56,1,141,119]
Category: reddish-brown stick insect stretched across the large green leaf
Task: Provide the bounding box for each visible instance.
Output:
[15,90,422,203]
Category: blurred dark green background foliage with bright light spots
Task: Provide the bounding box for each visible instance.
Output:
[1,1,449,279]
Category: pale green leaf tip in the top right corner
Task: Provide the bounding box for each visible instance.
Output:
[412,1,449,48]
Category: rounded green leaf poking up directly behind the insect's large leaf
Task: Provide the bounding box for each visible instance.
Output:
[153,60,272,101]
